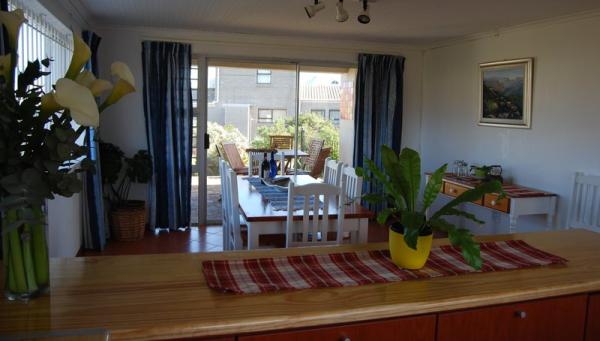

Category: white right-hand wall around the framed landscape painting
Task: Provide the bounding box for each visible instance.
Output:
[420,15,600,233]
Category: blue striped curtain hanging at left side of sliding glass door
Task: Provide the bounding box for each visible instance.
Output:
[142,41,193,229]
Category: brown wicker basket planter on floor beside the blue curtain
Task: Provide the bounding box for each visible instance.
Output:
[110,200,146,241]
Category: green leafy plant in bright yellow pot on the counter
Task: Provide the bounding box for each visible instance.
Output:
[356,146,504,269]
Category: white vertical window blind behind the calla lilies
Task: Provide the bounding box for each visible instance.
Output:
[8,0,73,92]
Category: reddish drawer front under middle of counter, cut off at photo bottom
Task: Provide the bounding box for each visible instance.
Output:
[238,315,435,341]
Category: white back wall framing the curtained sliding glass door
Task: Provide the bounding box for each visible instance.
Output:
[98,28,423,199]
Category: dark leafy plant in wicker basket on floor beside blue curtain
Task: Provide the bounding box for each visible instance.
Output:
[100,142,152,241]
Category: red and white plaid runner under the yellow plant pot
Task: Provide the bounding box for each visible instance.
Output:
[202,240,567,294]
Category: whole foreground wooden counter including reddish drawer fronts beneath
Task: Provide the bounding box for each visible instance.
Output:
[0,230,600,341]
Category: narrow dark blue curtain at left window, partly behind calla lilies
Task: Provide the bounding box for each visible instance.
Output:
[81,31,106,250]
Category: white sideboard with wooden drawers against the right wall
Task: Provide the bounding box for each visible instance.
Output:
[426,173,557,233]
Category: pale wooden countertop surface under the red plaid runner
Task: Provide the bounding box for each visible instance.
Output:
[0,230,600,340]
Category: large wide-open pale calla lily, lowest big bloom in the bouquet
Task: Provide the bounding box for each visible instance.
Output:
[54,78,100,127]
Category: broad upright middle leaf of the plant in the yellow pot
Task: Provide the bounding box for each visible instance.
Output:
[398,147,421,211]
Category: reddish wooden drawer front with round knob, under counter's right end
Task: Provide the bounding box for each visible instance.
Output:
[437,295,587,341]
